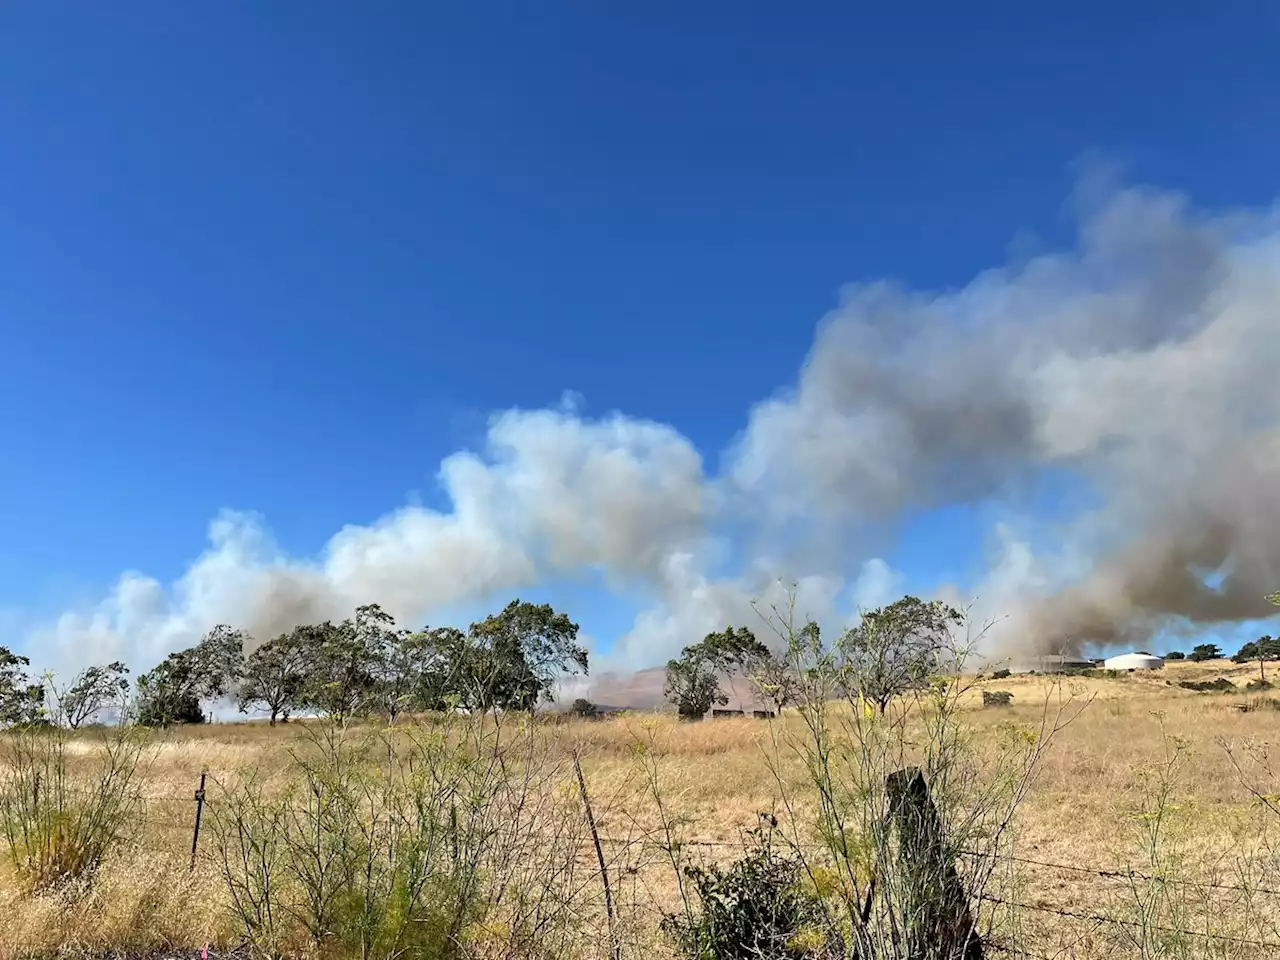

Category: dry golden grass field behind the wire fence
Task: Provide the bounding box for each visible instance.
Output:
[0,662,1280,959]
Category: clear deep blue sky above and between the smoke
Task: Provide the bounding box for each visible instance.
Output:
[0,3,1280,670]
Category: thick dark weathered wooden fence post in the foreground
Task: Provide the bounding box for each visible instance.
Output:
[884,767,983,960]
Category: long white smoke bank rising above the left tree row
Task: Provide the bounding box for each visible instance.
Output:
[29,411,710,668]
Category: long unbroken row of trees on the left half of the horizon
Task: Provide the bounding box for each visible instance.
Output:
[0,599,588,728]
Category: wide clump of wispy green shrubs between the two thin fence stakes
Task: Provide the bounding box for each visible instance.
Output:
[207,716,584,960]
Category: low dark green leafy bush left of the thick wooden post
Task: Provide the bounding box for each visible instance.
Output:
[662,828,844,960]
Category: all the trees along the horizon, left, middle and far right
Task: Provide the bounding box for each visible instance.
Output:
[0,594,1280,728]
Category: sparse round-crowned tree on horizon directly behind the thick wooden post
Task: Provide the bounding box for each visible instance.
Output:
[837,596,964,713]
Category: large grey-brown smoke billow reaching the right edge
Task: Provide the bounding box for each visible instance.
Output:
[732,180,1280,649]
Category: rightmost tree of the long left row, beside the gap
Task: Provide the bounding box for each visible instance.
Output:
[463,599,588,710]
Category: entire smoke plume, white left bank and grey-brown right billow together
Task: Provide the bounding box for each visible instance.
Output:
[28,176,1280,669]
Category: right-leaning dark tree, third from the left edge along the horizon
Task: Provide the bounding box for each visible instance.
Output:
[138,623,247,727]
